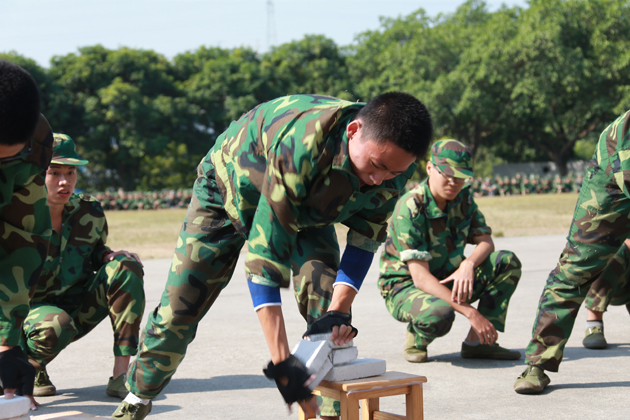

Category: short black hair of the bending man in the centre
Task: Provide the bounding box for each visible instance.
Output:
[355,92,433,158]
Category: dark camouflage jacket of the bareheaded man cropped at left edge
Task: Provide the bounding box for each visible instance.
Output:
[0,116,53,346]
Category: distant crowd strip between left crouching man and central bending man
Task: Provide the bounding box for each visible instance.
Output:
[93,189,192,210]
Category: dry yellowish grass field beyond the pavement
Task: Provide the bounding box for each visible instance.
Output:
[107,194,577,259]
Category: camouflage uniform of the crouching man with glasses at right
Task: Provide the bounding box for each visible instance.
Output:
[378,181,521,348]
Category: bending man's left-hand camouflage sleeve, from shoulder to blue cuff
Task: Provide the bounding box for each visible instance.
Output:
[245,136,317,287]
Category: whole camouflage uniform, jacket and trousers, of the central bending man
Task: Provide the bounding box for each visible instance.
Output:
[127,95,415,398]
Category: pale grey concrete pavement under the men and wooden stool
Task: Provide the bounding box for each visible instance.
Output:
[28,235,630,420]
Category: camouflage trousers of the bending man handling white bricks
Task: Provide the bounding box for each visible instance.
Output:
[127,162,339,398]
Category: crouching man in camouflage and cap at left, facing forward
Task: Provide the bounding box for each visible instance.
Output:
[22,134,145,398]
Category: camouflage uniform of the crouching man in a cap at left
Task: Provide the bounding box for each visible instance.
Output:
[22,194,144,367]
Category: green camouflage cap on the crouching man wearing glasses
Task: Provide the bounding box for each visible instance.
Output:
[431,139,473,178]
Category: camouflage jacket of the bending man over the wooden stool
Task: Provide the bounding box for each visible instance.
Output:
[205,95,416,287]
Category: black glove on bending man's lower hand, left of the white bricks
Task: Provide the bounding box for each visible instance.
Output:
[263,355,312,405]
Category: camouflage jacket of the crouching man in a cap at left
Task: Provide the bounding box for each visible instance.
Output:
[32,194,110,310]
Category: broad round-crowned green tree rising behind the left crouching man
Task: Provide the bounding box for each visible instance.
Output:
[50,45,199,190]
